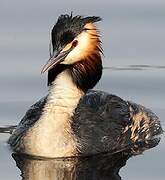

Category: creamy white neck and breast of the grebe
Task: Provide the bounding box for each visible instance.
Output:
[21,70,83,157]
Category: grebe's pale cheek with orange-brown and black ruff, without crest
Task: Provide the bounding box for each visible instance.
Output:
[48,23,102,91]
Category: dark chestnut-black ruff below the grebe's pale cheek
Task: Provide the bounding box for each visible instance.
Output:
[48,54,102,92]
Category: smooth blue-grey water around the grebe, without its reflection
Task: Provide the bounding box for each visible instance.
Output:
[0,0,165,180]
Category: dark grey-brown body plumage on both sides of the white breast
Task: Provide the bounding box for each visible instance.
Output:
[9,90,163,155]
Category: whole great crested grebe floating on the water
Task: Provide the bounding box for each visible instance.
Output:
[8,15,163,157]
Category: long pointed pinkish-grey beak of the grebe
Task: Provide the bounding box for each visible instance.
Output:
[41,47,72,73]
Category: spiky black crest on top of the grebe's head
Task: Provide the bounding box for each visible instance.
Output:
[51,14,101,50]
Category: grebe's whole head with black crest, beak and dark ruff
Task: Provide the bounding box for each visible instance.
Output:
[42,14,102,91]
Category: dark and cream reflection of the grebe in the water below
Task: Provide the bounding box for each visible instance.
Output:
[12,138,159,180]
